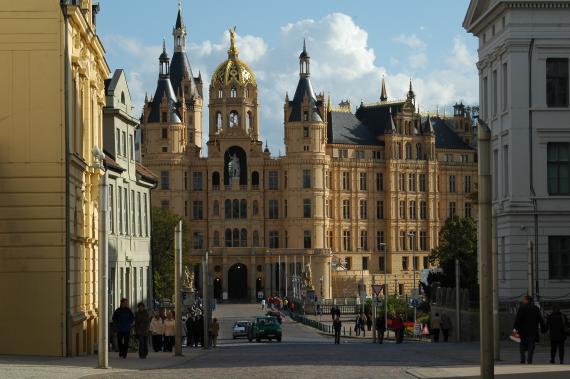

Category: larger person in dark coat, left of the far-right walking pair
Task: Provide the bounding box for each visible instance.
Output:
[514,296,546,364]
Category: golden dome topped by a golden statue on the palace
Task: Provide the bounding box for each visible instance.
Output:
[212,27,256,86]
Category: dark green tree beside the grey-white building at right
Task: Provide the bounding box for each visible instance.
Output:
[428,217,477,290]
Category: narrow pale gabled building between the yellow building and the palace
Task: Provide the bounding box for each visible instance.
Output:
[103,70,156,310]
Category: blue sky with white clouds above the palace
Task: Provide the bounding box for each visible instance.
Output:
[97,0,479,155]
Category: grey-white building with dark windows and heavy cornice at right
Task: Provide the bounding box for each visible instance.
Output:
[463,0,570,302]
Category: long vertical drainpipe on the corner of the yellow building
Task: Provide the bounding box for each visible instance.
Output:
[60,0,72,357]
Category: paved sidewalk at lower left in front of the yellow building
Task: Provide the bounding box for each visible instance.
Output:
[0,348,207,379]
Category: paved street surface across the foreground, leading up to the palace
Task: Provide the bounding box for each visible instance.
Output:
[0,304,570,379]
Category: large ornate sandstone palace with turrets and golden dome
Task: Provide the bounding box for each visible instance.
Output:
[141,4,477,301]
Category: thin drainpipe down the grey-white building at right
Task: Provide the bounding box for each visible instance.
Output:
[528,38,540,303]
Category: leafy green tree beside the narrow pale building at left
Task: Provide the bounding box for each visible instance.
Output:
[151,208,190,300]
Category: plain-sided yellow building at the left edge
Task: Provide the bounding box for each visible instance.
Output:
[0,0,110,356]
